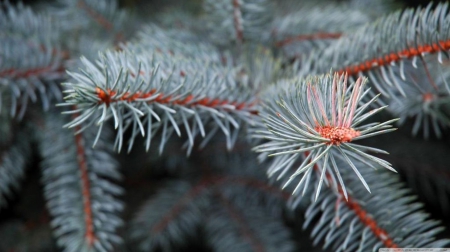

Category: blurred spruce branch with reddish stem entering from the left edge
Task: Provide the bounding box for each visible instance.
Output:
[0,2,67,118]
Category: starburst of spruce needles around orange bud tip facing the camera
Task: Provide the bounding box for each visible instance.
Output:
[253,73,397,198]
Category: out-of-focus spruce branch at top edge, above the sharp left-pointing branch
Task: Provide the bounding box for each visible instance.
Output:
[42,0,136,61]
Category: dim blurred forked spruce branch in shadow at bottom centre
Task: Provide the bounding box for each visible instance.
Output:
[131,140,292,251]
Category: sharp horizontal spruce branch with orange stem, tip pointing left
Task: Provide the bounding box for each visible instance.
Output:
[64,42,256,153]
